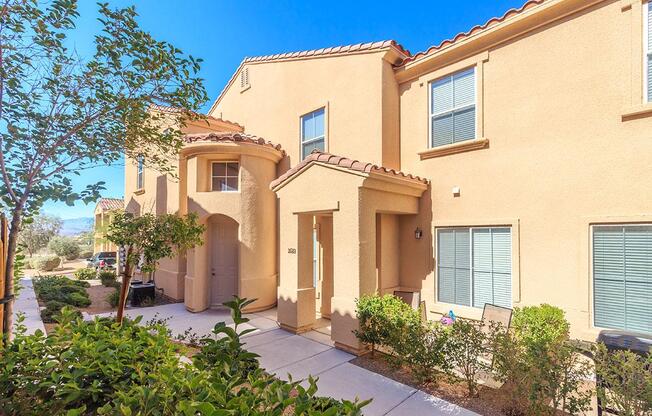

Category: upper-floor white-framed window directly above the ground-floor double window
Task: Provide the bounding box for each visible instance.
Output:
[430,67,476,147]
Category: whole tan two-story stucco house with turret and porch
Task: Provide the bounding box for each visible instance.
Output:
[126,0,652,352]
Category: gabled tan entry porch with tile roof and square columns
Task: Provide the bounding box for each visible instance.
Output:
[271,153,428,354]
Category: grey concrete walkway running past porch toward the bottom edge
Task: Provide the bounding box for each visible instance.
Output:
[91,303,477,416]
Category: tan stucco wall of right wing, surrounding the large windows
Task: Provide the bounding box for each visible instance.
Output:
[401,1,652,338]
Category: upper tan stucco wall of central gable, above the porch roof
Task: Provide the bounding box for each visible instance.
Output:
[211,51,398,167]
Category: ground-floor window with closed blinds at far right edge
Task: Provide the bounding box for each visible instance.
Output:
[593,225,652,332]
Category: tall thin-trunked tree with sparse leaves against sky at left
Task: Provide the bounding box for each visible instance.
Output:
[0,0,207,331]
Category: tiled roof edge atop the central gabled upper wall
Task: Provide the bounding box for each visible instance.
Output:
[208,40,411,113]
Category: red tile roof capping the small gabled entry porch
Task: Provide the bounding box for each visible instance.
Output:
[270,150,428,188]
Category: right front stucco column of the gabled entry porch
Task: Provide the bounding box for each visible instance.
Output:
[331,201,376,354]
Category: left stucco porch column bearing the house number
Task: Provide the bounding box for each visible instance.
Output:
[277,213,316,332]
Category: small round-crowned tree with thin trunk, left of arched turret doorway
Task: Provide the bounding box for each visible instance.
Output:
[106,212,205,323]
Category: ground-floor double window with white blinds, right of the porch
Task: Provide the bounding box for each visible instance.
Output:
[437,227,512,308]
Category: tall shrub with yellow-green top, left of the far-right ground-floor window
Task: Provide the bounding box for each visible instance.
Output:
[493,305,591,415]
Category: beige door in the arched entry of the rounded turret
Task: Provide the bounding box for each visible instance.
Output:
[211,217,238,306]
